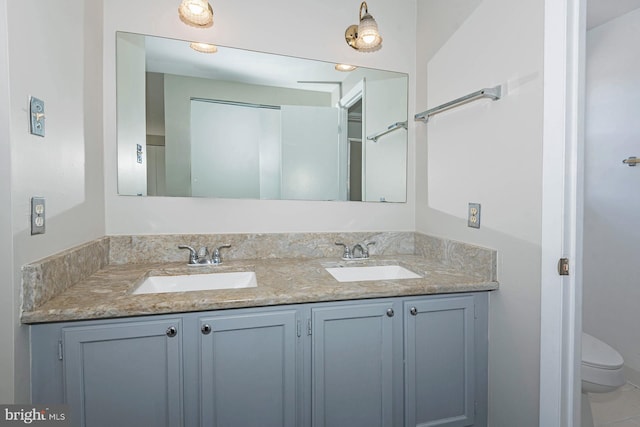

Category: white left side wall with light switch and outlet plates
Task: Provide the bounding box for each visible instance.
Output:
[0,0,105,403]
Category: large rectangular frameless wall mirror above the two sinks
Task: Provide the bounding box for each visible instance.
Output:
[116,32,408,202]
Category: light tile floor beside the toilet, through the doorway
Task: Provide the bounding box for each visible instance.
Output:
[589,384,640,427]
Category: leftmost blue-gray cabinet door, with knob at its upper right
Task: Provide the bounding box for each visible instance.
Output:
[62,319,182,427]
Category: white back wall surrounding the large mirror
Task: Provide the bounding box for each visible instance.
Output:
[104,0,416,234]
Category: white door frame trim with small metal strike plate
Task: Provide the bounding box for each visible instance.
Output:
[540,0,586,427]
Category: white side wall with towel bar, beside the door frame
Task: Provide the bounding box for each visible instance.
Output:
[416,0,544,427]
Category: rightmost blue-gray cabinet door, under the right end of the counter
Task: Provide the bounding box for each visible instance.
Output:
[404,296,475,427]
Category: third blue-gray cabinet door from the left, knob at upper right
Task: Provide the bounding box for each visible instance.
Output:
[311,302,401,427]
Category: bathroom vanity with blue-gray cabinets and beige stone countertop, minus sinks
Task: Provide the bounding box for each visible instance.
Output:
[23,234,498,427]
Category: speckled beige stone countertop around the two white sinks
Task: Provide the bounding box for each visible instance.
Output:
[21,233,498,323]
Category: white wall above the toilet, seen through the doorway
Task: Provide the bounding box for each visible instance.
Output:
[583,9,640,384]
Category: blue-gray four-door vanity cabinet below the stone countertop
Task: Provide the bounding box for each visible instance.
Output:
[30,292,488,427]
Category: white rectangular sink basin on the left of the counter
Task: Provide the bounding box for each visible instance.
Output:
[133,271,258,295]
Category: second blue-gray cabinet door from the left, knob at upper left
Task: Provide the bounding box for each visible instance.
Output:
[200,310,299,427]
